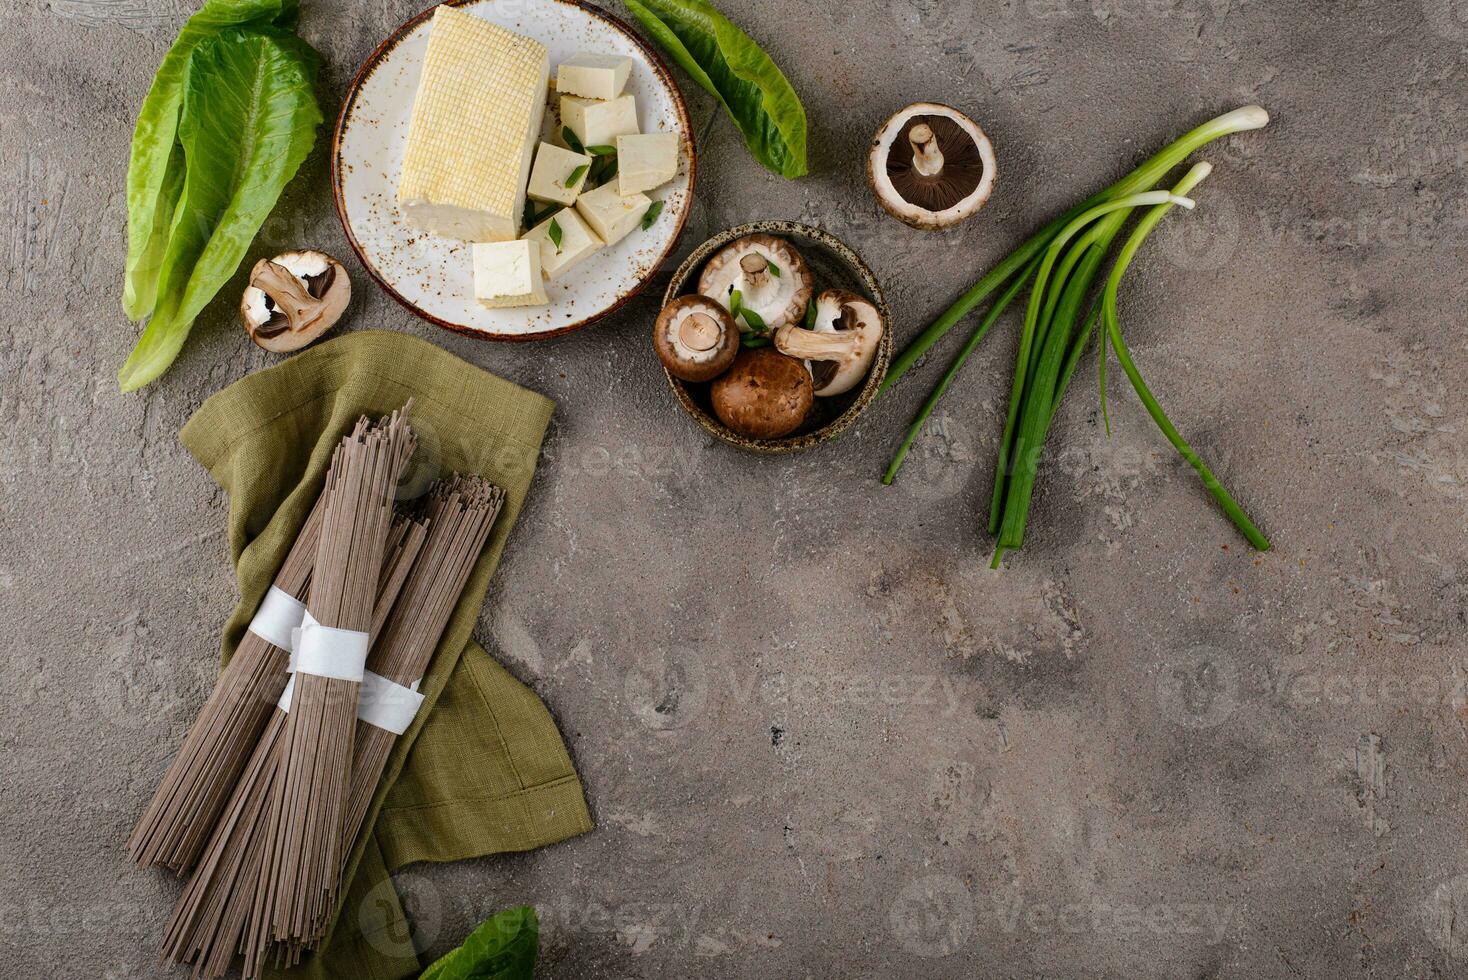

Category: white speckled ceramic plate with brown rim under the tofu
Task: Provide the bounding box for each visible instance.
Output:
[332,0,696,340]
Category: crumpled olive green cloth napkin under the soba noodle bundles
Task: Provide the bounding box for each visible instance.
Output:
[179,332,592,980]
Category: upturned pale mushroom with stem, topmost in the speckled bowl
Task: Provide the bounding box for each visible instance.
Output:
[699,235,812,334]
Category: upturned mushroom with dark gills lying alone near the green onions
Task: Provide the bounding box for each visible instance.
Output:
[866,103,998,230]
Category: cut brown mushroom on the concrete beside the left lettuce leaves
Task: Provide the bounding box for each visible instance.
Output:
[239,251,352,354]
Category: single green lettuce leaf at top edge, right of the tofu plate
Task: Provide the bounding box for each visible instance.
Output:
[625,0,807,179]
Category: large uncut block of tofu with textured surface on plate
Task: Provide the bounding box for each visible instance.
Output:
[398,6,551,242]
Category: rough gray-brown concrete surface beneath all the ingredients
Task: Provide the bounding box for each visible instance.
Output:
[0,0,1468,979]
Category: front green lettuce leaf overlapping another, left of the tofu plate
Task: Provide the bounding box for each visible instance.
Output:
[117,28,321,392]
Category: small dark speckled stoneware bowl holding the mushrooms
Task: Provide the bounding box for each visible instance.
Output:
[666,222,893,453]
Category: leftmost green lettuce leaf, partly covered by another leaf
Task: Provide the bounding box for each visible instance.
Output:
[122,0,298,320]
